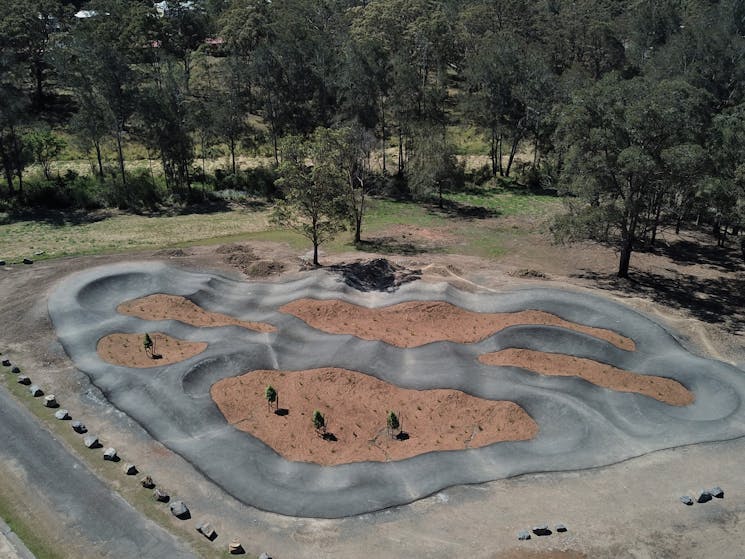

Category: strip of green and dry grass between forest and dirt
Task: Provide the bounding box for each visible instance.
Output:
[0,188,561,263]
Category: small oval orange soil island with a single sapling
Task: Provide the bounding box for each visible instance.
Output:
[96,332,207,369]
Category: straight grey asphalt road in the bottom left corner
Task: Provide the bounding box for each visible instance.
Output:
[0,388,196,559]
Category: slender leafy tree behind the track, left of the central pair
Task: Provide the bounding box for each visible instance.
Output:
[272,128,347,266]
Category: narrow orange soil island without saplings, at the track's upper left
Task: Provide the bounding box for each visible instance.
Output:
[116,293,276,332]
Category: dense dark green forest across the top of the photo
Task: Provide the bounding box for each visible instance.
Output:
[0,0,745,277]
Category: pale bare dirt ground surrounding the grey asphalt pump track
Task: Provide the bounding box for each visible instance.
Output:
[0,224,745,559]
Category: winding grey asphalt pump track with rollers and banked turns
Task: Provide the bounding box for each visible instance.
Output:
[49,263,745,518]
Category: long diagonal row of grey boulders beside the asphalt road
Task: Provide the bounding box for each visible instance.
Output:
[0,353,272,559]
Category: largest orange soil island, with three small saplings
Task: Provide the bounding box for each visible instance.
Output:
[211,368,538,466]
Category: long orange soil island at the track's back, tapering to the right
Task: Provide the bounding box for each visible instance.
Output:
[280,299,635,351]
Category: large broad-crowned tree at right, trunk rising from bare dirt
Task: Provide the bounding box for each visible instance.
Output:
[556,75,707,278]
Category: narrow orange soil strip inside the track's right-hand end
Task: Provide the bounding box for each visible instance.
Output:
[479,348,694,406]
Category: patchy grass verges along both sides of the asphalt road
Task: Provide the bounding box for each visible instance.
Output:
[0,367,228,559]
